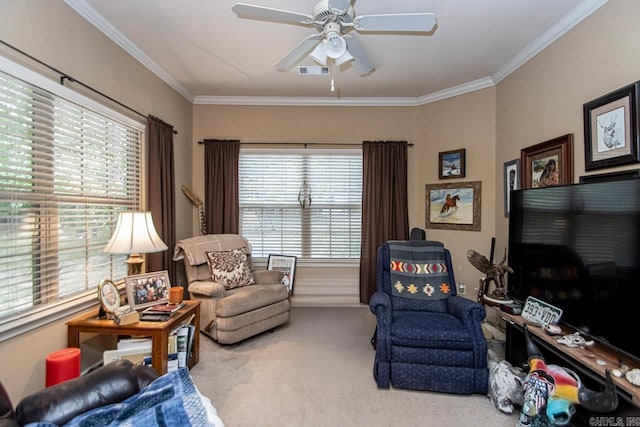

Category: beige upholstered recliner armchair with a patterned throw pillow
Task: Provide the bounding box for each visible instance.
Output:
[173,234,290,344]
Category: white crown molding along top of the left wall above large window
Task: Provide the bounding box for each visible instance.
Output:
[64,0,195,103]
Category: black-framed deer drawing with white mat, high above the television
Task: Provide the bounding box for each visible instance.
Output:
[583,81,640,170]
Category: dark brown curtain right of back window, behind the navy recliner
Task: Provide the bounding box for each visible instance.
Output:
[360,141,409,304]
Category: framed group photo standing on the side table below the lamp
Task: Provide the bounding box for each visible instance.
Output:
[125,270,171,310]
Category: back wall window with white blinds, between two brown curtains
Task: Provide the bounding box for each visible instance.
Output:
[239,149,362,260]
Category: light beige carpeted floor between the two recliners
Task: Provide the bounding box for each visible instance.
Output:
[191,307,517,427]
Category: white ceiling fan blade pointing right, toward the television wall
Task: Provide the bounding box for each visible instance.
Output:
[353,13,436,32]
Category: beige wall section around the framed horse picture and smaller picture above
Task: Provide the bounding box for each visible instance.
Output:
[409,88,496,292]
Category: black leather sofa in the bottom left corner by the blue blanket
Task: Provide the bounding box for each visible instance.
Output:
[0,359,158,427]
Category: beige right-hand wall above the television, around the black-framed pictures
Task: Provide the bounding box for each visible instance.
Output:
[494,0,640,252]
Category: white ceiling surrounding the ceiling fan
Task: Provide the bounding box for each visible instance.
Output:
[65,0,607,105]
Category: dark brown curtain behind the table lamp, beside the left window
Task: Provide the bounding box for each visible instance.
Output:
[147,116,178,284]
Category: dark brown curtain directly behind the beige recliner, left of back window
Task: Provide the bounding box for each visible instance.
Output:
[203,139,240,234]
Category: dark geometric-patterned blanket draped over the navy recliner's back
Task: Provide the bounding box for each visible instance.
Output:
[389,241,452,300]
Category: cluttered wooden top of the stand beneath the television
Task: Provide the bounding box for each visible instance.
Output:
[494,307,640,406]
